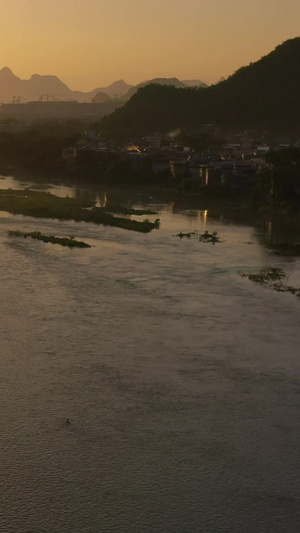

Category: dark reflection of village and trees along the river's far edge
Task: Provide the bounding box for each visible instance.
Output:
[28,174,300,252]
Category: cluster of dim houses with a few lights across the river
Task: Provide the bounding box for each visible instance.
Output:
[62,127,284,189]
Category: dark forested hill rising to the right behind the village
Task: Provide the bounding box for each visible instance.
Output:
[101,37,300,134]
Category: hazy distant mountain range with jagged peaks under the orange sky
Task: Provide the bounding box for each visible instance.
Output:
[0,67,205,103]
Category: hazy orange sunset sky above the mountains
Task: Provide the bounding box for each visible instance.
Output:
[0,0,300,90]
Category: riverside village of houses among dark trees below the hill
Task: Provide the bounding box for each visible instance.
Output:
[62,125,293,192]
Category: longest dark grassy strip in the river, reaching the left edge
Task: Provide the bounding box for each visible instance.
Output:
[0,189,160,233]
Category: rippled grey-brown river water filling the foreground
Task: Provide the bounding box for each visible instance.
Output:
[0,180,300,533]
